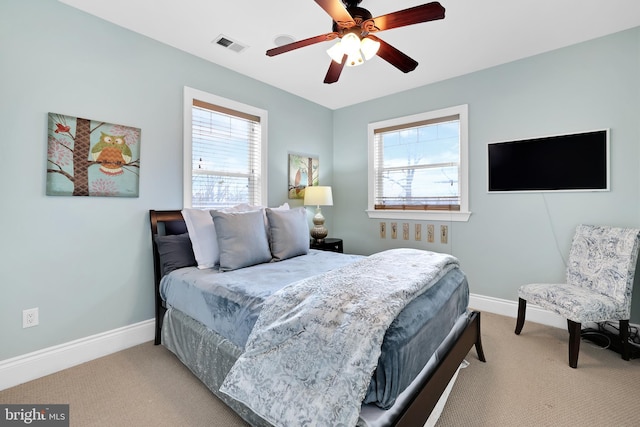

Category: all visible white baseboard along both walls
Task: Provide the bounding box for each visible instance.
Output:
[0,294,567,390]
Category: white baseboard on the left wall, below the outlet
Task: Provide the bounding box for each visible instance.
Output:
[0,319,155,390]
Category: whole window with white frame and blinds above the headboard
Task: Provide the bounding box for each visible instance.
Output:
[184,87,267,208]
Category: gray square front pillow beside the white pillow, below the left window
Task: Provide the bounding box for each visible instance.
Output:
[210,209,271,271]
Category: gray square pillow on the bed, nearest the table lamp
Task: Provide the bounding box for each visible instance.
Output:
[266,208,309,261]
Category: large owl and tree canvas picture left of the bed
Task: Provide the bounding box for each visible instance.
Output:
[47,113,141,197]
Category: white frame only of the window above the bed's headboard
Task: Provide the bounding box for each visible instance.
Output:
[182,86,269,208]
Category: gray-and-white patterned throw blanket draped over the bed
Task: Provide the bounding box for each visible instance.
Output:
[220,249,458,427]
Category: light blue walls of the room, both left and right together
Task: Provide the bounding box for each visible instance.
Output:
[0,0,640,360]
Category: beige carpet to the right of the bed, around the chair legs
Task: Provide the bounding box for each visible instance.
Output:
[437,313,640,427]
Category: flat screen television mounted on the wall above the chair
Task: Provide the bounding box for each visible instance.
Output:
[488,129,609,192]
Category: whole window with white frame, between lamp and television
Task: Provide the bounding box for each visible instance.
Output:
[367,105,470,221]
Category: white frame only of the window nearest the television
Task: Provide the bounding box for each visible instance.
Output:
[366,104,471,222]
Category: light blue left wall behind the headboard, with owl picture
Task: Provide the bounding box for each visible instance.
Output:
[0,0,333,360]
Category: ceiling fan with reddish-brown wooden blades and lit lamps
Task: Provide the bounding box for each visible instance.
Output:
[267,0,445,83]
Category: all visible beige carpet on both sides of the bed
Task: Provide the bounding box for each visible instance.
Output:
[0,313,640,427]
